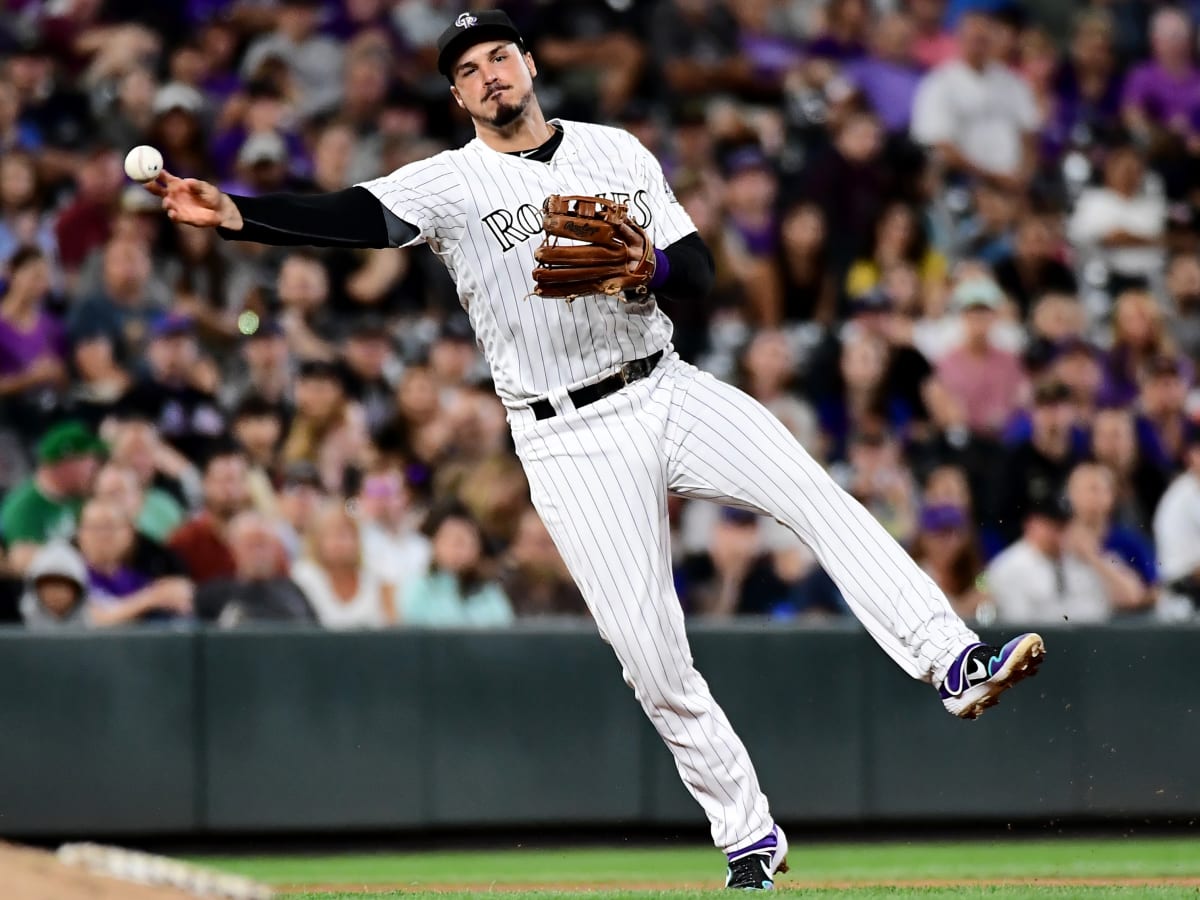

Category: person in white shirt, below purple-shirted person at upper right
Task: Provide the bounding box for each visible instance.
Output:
[1069,145,1166,288]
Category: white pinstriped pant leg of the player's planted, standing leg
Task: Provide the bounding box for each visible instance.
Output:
[514,376,774,851]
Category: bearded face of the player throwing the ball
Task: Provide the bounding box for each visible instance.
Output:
[450,43,538,128]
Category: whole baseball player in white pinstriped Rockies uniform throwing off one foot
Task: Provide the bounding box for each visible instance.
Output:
[148,11,1044,889]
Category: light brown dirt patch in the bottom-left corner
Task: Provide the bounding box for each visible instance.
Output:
[0,842,191,900]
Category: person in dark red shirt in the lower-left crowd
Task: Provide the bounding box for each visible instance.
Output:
[168,446,250,584]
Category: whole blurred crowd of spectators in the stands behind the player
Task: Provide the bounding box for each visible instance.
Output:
[0,0,1200,629]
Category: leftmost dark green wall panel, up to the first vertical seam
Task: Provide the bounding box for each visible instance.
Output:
[0,630,198,835]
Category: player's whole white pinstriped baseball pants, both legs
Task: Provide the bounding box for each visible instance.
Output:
[509,350,978,851]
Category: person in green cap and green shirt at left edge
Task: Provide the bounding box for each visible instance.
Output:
[0,421,104,572]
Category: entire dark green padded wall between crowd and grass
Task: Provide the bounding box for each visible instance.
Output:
[0,623,1200,838]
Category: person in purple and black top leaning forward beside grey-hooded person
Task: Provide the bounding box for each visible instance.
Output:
[79,499,193,625]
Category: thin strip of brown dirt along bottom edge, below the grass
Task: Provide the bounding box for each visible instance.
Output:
[278,877,1200,894]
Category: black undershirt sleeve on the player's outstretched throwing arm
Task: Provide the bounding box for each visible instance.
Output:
[217,186,419,248]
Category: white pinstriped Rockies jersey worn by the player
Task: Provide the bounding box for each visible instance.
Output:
[361,120,696,407]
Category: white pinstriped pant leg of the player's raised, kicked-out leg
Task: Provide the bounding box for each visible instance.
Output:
[667,362,978,683]
